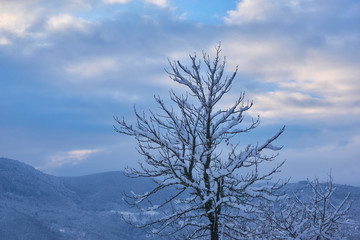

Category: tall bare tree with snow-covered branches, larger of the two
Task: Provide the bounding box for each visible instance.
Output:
[115,46,284,240]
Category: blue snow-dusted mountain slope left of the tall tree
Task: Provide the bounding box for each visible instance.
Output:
[0,158,148,240]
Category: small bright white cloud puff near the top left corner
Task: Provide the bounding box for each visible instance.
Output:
[46,14,87,31]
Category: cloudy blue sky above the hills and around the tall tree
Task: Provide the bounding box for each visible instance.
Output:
[0,0,360,186]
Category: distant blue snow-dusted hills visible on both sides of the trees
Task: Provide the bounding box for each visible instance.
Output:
[0,158,360,240]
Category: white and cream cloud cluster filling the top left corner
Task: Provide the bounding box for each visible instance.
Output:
[0,0,91,47]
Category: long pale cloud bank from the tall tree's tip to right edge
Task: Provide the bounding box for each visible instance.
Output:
[224,37,360,119]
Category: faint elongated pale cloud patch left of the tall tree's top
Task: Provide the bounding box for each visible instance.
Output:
[66,58,119,78]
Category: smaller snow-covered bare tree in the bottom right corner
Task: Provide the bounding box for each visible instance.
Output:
[263,175,351,240]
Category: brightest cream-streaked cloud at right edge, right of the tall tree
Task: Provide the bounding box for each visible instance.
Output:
[248,53,360,119]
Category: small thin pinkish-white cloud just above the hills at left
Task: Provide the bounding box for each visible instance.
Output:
[46,149,100,168]
